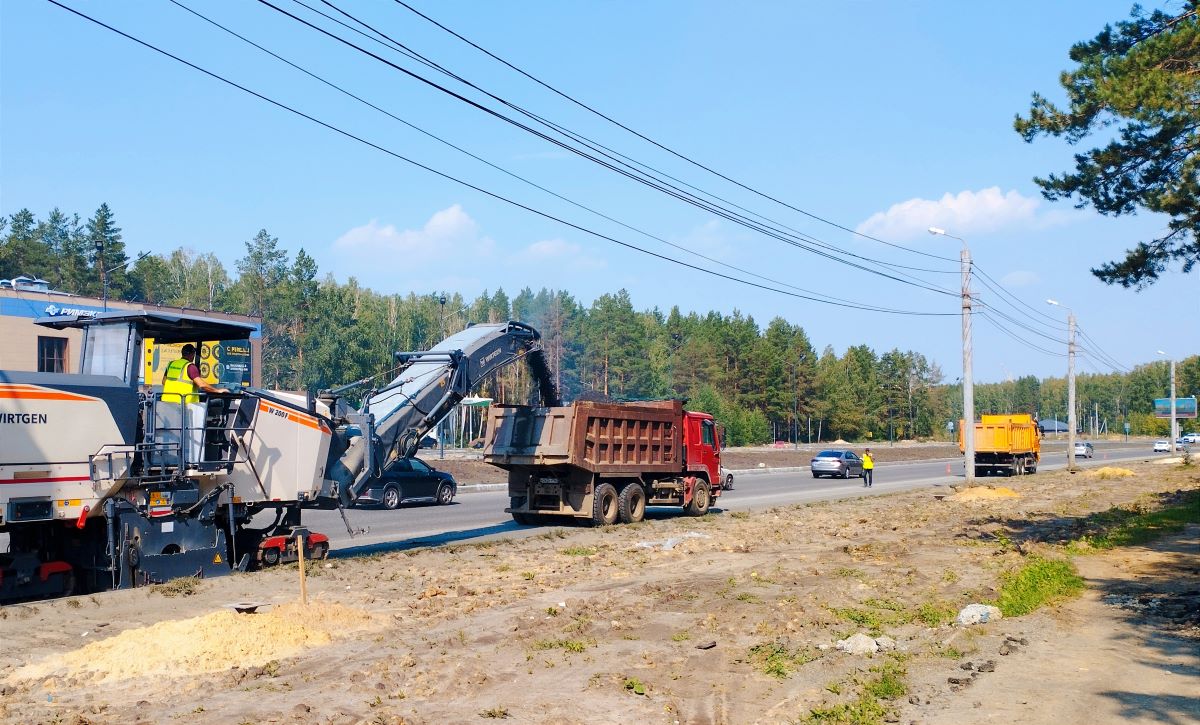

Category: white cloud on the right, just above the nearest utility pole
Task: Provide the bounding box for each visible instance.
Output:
[857,186,1049,240]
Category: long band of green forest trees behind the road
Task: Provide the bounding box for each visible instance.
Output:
[0,204,1200,445]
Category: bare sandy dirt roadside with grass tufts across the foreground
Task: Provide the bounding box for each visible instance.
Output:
[0,465,1200,725]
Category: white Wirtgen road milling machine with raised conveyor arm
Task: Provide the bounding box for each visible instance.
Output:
[0,311,558,604]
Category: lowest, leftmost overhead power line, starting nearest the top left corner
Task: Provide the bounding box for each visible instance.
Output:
[47,0,958,317]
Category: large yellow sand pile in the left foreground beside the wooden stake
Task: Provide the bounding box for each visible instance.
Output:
[13,603,374,681]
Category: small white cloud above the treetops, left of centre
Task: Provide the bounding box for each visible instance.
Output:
[334,204,494,262]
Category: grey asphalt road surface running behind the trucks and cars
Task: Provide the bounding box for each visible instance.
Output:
[304,442,1152,556]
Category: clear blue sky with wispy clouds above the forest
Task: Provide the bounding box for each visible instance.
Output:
[0,0,1200,382]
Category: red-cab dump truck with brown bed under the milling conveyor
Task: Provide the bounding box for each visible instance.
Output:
[484,400,721,526]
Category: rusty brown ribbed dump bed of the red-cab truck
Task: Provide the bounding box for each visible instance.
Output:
[484,401,683,477]
